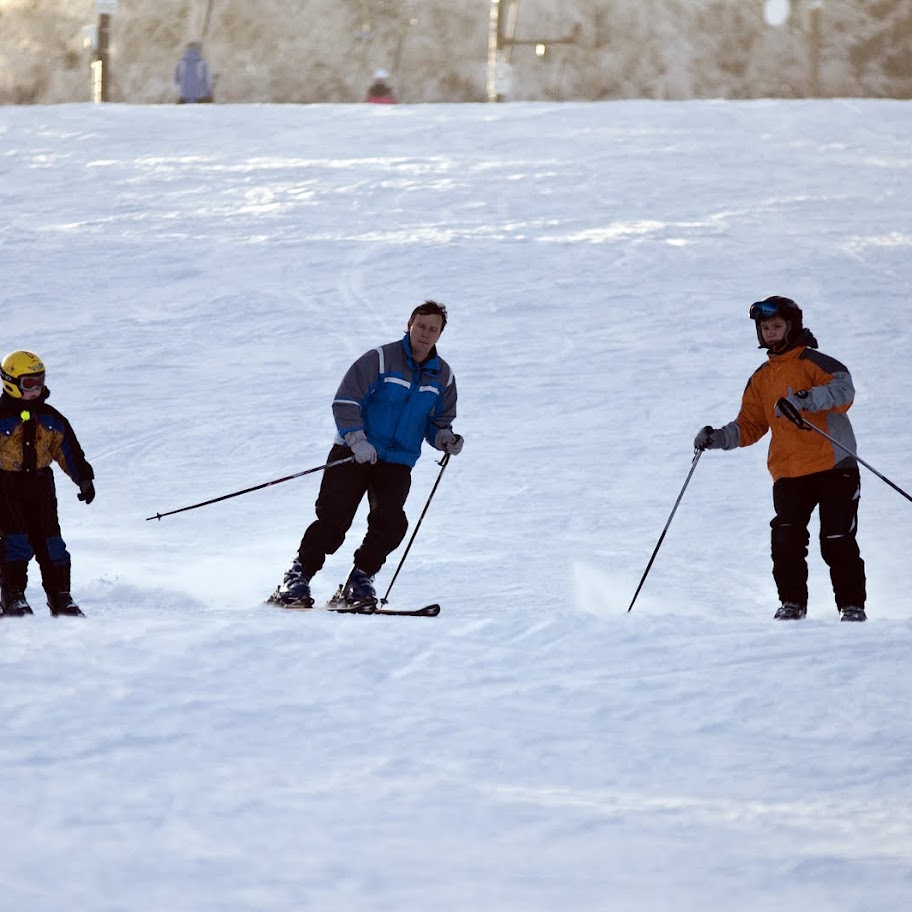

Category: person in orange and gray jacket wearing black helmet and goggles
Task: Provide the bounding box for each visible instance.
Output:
[694,295,867,621]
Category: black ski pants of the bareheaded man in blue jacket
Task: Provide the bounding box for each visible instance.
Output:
[298,446,412,577]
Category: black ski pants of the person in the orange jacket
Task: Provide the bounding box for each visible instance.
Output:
[770,468,866,608]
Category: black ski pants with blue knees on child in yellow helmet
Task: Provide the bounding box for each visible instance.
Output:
[0,468,70,604]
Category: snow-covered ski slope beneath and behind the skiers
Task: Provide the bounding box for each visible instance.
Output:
[0,101,912,912]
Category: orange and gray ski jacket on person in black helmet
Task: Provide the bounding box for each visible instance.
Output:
[721,330,857,481]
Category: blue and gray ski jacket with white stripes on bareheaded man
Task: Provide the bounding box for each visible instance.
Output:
[333,333,456,466]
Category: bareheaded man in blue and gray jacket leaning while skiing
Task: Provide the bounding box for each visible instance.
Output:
[272,301,463,609]
